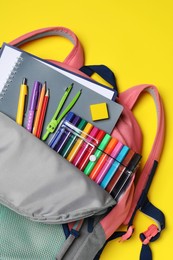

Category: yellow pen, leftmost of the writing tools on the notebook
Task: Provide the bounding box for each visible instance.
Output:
[16,78,28,125]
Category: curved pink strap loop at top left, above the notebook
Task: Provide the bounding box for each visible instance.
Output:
[9,27,84,69]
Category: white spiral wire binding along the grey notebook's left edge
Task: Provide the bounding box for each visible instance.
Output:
[0,57,23,101]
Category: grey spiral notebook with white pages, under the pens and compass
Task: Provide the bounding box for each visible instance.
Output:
[0,43,123,139]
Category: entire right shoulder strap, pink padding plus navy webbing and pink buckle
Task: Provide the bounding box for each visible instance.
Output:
[121,84,165,260]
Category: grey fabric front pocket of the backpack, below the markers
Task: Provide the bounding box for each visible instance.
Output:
[0,113,115,223]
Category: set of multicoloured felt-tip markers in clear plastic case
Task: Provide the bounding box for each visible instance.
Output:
[51,112,141,200]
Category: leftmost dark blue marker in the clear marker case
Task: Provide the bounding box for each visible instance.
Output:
[48,111,75,148]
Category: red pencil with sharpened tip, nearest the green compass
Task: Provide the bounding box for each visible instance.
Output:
[36,89,49,138]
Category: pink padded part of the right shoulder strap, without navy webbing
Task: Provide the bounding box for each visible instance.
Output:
[121,84,165,223]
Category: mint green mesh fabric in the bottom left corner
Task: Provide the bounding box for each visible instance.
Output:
[0,204,65,260]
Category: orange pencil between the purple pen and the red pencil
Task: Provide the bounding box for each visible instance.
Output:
[32,82,46,135]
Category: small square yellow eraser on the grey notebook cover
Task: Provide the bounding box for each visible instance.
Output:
[90,103,109,121]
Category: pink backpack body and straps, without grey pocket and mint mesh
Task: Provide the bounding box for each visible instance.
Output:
[0,27,165,260]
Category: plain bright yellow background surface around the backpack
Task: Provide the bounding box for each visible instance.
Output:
[0,0,173,260]
